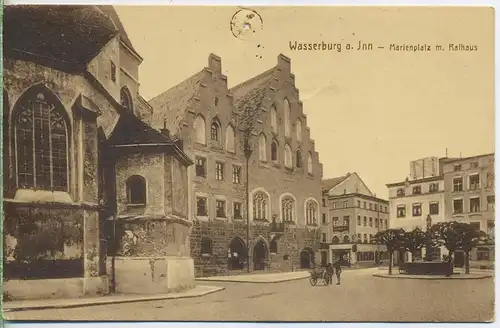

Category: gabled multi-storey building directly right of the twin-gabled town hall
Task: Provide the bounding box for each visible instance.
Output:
[321,173,389,266]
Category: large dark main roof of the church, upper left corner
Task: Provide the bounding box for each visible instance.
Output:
[4,5,119,70]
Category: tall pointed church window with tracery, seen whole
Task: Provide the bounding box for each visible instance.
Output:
[13,86,69,191]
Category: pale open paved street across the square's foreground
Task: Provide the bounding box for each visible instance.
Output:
[5,270,494,322]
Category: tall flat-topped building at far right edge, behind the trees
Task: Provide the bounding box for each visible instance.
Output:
[443,154,495,264]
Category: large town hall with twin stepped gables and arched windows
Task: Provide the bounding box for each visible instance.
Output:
[149,54,322,276]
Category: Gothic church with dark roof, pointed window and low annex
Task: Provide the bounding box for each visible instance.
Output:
[3,6,194,300]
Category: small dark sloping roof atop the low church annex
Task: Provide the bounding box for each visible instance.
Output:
[108,112,173,146]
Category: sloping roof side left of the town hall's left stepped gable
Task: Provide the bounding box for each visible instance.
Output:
[149,70,204,135]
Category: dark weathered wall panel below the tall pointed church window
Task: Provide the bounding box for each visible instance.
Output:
[3,203,84,280]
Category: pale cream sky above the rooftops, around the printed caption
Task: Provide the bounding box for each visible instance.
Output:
[116,6,495,199]
